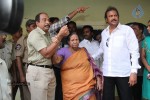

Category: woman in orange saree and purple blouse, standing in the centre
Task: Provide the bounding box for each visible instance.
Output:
[53,33,102,100]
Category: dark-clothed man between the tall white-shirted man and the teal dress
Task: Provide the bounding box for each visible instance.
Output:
[130,22,144,100]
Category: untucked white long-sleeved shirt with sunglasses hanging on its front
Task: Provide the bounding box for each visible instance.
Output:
[92,24,141,77]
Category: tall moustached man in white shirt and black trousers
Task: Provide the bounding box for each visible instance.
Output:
[93,7,140,100]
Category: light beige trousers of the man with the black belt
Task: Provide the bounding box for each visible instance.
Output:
[26,65,56,100]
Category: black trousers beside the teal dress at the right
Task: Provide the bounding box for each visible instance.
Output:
[132,76,143,100]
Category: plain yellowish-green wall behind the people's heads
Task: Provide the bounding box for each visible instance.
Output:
[22,0,150,32]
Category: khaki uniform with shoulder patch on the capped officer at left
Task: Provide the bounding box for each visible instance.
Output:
[15,35,31,100]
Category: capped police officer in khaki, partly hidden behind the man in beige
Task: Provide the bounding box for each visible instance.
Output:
[16,19,36,100]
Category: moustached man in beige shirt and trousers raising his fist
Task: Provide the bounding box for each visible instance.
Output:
[26,12,69,100]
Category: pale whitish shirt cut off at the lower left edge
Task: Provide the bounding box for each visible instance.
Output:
[0,58,12,100]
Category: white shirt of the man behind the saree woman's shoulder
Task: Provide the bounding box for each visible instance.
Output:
[79,39,102,67]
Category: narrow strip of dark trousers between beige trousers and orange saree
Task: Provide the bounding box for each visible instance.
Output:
[54,67,63,100]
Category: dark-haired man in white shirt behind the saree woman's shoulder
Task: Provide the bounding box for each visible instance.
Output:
[79,25,102,67]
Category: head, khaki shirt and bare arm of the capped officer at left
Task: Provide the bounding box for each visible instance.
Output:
[16,19,36,82]
